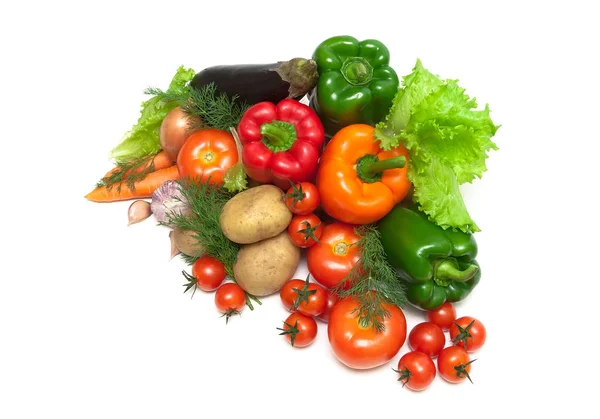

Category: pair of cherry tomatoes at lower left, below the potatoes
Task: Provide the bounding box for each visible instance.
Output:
[184,256,246,323]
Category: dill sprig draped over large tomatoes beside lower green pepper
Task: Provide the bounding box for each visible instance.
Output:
[333,224,406,332]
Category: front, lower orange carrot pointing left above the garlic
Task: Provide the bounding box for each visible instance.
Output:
[85,164,179,202]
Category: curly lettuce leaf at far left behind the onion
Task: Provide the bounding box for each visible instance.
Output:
[110,66,196,163]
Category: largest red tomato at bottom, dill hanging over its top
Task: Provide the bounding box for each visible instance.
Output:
[327,298,406,369]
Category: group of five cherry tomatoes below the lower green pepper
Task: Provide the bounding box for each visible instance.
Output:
[394,302,486,391]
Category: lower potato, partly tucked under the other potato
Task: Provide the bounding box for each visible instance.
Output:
[233,231,301,297]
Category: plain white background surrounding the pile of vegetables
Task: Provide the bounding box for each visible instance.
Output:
[0,1,600,419]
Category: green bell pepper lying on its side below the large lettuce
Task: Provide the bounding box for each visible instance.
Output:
[378,204,481,310]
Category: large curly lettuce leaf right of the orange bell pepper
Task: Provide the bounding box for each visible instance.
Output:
[375,60,499,232]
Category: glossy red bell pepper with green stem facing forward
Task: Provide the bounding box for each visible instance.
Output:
[237,99,325,190]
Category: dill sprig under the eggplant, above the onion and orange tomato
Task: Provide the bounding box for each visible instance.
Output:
[145,83,248,130]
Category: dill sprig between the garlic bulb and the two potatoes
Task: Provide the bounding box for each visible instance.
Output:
[160,178,261,310]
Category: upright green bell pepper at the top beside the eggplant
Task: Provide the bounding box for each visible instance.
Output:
[310,36,398,137]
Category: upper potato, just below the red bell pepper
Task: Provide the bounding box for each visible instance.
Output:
[220,185,292,244]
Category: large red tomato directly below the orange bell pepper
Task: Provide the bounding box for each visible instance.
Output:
[306,223,360,288]
